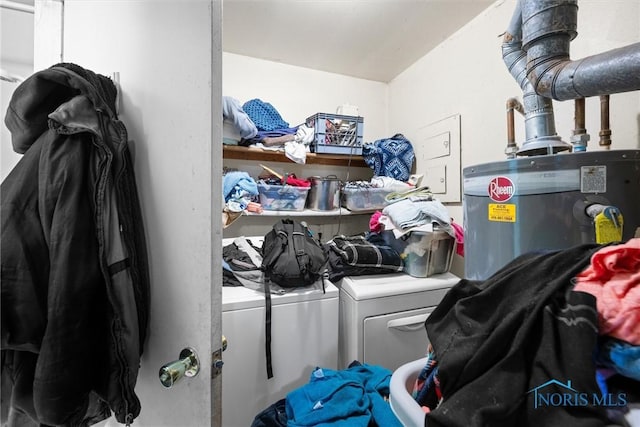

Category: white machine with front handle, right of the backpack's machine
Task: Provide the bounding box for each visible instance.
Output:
[337,273,460,371]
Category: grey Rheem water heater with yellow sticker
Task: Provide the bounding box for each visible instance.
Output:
[463,150,640,280]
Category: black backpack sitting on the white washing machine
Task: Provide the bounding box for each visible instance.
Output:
[261,219,328,288]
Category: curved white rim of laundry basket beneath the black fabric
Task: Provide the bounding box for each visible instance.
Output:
[389,357,427,427]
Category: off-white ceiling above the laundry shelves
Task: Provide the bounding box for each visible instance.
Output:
[223,0,493,82]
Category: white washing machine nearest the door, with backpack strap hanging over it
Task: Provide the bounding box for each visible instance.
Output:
[222,281,338,427]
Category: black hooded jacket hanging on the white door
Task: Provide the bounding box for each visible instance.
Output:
[0,63,149,426]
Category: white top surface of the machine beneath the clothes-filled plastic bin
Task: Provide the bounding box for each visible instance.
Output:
[338,272,460,301]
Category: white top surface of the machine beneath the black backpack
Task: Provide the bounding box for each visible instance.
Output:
[222,280,338,312]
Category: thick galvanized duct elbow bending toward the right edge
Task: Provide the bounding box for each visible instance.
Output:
[521,0,640,101]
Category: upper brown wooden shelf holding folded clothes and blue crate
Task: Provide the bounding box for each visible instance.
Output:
[222,145,368,168]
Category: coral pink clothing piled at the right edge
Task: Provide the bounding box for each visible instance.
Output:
[574,238,640,345]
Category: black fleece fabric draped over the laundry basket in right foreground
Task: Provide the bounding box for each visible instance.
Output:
[425,244,607,427]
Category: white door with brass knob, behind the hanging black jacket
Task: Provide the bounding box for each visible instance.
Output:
[34,0,222,427]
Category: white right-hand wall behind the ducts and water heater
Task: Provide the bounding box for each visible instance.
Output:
[389,0,640,227]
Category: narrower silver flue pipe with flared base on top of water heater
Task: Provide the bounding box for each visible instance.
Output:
[502,0,571,156]
